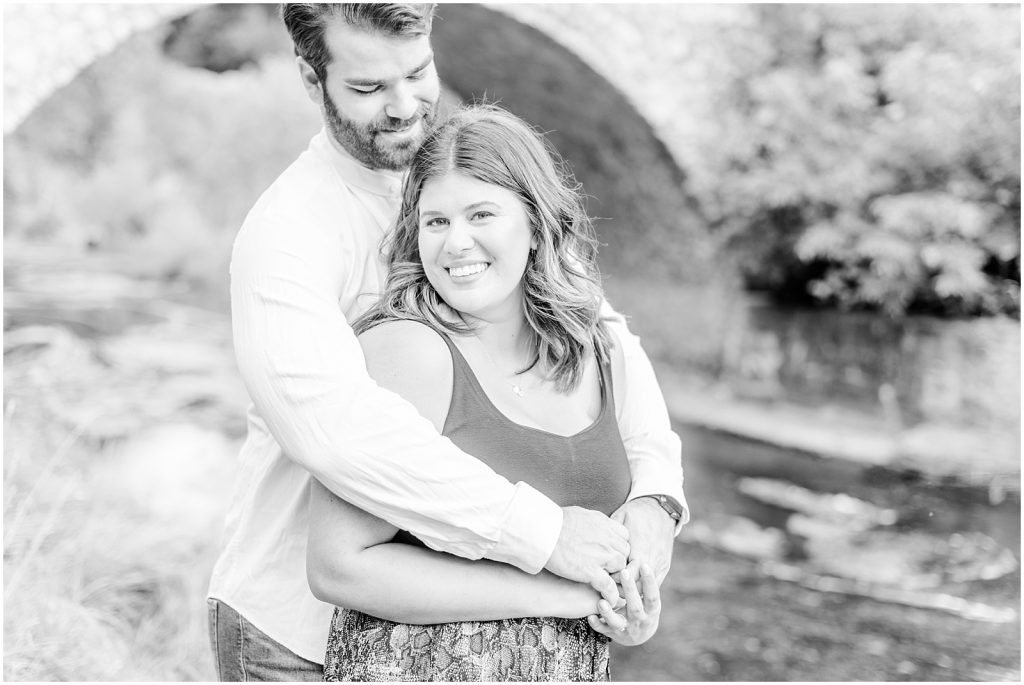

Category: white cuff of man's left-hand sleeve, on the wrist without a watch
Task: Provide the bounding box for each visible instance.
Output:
[484,481,562,573]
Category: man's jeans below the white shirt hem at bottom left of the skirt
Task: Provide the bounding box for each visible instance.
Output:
[206,597,324,682]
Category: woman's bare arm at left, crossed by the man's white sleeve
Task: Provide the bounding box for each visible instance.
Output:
[306,322,599,624]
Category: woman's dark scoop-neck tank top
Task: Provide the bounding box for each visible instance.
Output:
[435,329,632,514]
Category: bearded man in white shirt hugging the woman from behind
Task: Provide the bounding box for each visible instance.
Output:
[209,4,688,681]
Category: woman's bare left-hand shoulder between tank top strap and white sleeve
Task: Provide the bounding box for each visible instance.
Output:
[358,319,453,431]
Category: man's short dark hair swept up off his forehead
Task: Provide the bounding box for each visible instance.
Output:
[281,2,436,83]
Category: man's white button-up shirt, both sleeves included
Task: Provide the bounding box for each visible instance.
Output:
[210,130,684,663]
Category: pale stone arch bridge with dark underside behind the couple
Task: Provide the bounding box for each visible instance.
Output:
[3,3,743,280]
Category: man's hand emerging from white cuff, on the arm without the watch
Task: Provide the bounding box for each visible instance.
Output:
[544,505,630,606]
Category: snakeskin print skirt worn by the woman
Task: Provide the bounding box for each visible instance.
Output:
[324,609,609,682]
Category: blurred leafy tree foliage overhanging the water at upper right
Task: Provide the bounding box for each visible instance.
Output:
[701,5,1020,315]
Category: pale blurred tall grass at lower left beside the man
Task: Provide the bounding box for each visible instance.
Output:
[3,335,219,681]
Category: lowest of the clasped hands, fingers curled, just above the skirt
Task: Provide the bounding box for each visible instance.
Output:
[587,561,662,646]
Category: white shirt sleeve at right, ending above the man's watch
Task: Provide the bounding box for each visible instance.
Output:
[601,300,690,534]
